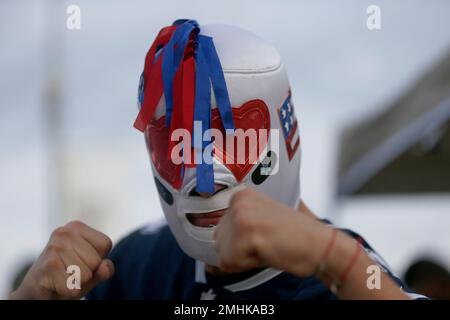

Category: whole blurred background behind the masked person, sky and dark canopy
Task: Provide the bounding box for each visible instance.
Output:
[0,0,450,298]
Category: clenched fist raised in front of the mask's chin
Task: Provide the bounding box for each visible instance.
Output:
[214,188,329,276]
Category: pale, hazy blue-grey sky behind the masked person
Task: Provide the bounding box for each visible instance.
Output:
[0,0,450,296]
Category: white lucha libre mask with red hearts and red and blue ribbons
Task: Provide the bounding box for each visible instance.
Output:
[135,20,300,266]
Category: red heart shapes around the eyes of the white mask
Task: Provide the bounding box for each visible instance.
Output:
[145,99,270,189]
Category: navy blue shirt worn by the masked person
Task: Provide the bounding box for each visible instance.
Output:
[86,221,424,300]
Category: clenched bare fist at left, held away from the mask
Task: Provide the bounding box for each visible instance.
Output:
[10,221,114,299]
